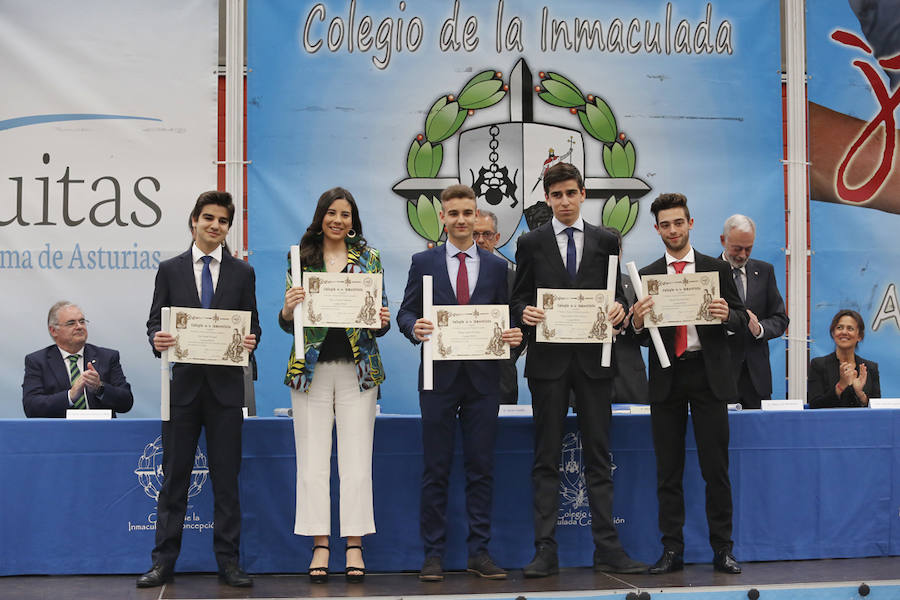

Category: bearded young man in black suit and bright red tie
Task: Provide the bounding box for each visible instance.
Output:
[632,194,747,574]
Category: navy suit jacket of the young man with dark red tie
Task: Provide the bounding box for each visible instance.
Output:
[397,246,513,394]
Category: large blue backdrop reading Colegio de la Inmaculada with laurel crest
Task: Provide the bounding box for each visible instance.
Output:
[247,0,784,415]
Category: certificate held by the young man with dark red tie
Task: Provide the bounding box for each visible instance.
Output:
[431,304,509,360]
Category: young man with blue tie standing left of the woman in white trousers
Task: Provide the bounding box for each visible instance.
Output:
[137,191,261,587]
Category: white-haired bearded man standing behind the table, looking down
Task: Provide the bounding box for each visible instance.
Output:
[719,215,788,408]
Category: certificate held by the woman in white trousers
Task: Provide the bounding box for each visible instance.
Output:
[303,271,381,329]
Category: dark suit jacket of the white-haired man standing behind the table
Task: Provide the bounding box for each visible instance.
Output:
[728,258,790,398]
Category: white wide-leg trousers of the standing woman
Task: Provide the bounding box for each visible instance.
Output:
[291,361,378,537]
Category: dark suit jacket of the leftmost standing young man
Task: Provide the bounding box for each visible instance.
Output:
[147,250,262,406]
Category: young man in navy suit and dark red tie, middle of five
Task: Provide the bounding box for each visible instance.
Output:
[397,185,522,581]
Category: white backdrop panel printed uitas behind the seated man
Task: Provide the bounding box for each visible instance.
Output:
[0,0,218,417]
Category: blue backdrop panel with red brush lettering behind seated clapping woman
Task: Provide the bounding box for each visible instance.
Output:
[806,0,900,400]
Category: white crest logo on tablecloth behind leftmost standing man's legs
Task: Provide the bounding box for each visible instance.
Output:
[128,436,213,531]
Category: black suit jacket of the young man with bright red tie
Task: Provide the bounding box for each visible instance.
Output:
[640,249,747,404]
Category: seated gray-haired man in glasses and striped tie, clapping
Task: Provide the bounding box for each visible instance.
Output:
[22,300,134,417]
